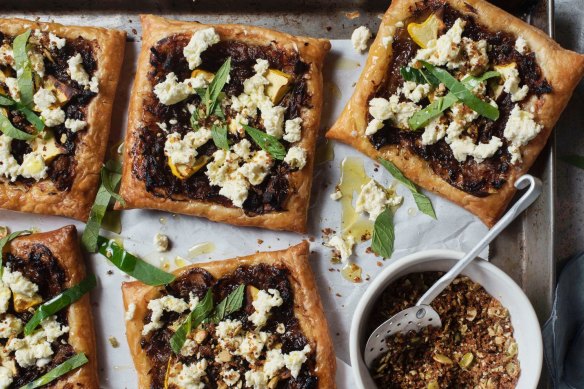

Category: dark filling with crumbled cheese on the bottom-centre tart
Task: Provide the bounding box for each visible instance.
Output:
[139,265,318,389]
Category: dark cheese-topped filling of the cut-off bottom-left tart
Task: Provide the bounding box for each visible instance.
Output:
[0,244,75,388]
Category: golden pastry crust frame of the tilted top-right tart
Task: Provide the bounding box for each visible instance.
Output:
[326,0,584,226]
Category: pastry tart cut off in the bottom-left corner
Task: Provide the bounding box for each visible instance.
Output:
[0,226,99,388]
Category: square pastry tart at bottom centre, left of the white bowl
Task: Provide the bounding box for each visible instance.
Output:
[122,242,336,389]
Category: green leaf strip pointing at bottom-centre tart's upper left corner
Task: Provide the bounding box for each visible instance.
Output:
[97,235,176,286]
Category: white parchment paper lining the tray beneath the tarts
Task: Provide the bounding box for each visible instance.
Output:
[0,40,487,388]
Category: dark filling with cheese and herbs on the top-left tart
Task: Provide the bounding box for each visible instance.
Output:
[0,29,99,191]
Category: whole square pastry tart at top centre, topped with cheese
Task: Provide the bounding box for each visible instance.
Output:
[120,16,330,232]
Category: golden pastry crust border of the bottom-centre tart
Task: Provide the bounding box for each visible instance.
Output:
[122,241,336,389]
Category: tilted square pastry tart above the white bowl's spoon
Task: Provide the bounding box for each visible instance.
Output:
[327,0,584,226]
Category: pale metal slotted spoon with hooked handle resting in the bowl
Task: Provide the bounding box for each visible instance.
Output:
[365,174,541,367]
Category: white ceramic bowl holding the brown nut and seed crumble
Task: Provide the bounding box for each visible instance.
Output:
[349,250,543,389]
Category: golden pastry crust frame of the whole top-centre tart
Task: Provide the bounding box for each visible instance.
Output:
[116,15,330,232]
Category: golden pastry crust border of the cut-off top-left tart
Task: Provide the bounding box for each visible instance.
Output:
[0,19,126,221]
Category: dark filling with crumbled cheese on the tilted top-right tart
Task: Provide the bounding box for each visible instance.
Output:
[366,1,552,196]
